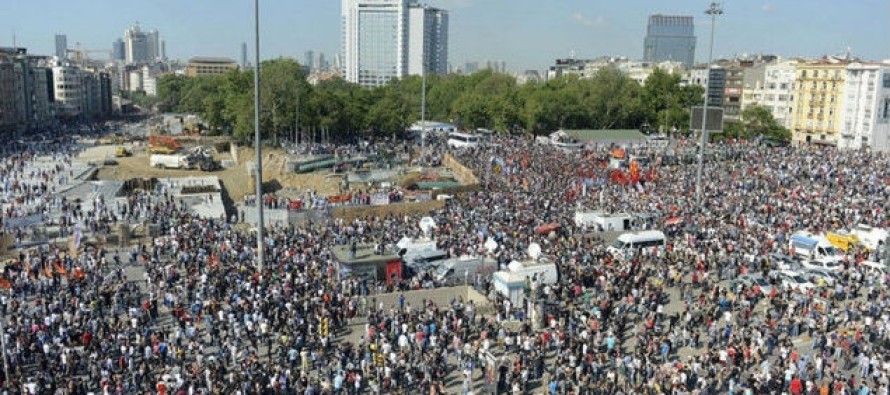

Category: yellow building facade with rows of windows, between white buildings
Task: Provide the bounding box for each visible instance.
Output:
[791,59,849,145]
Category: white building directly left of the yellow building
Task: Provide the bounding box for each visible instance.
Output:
[742,60,797,129]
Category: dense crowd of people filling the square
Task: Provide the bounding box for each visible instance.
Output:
[0,127,890,395]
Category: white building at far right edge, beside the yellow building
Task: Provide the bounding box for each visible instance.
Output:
[838,62,890,152]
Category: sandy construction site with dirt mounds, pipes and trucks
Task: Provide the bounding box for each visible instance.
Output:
[79,116,476,223]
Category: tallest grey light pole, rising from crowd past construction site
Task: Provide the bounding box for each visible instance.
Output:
[253,0,264,273]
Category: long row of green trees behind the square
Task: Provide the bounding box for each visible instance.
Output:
[157,58,788,140]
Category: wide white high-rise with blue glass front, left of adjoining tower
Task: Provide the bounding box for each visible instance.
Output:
[340,0,408,87]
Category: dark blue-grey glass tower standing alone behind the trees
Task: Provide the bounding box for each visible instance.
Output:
[643,14,695,68]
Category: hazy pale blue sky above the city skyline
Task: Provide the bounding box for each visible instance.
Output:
[0,0,890,71]
